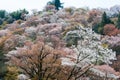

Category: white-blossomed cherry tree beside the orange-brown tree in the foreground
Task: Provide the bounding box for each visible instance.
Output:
[62,27,116,79]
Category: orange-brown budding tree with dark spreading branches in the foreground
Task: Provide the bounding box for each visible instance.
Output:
[7,43,61,80]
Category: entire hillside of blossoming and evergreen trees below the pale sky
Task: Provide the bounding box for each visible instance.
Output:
[0,0,120,80]
